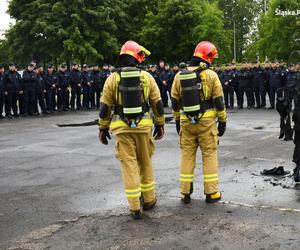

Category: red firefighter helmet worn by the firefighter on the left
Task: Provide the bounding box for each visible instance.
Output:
[120,41,151,63]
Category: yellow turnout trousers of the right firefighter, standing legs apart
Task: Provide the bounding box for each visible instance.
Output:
[180,118,219,194]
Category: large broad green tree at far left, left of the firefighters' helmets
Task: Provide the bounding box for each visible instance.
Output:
[2,0,119,63]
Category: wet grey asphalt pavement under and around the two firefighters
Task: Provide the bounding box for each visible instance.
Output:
[0,110,300,250]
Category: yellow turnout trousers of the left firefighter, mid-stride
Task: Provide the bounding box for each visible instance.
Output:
[116,133,155,211]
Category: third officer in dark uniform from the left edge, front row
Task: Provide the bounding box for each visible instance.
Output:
[22,64,37,115]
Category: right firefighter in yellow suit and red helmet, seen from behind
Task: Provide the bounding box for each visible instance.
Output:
[171,41,227,203]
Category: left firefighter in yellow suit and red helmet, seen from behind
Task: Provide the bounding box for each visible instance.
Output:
[99,41,165,219]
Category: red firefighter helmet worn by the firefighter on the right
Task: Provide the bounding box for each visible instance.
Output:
[194,41,218,63]
